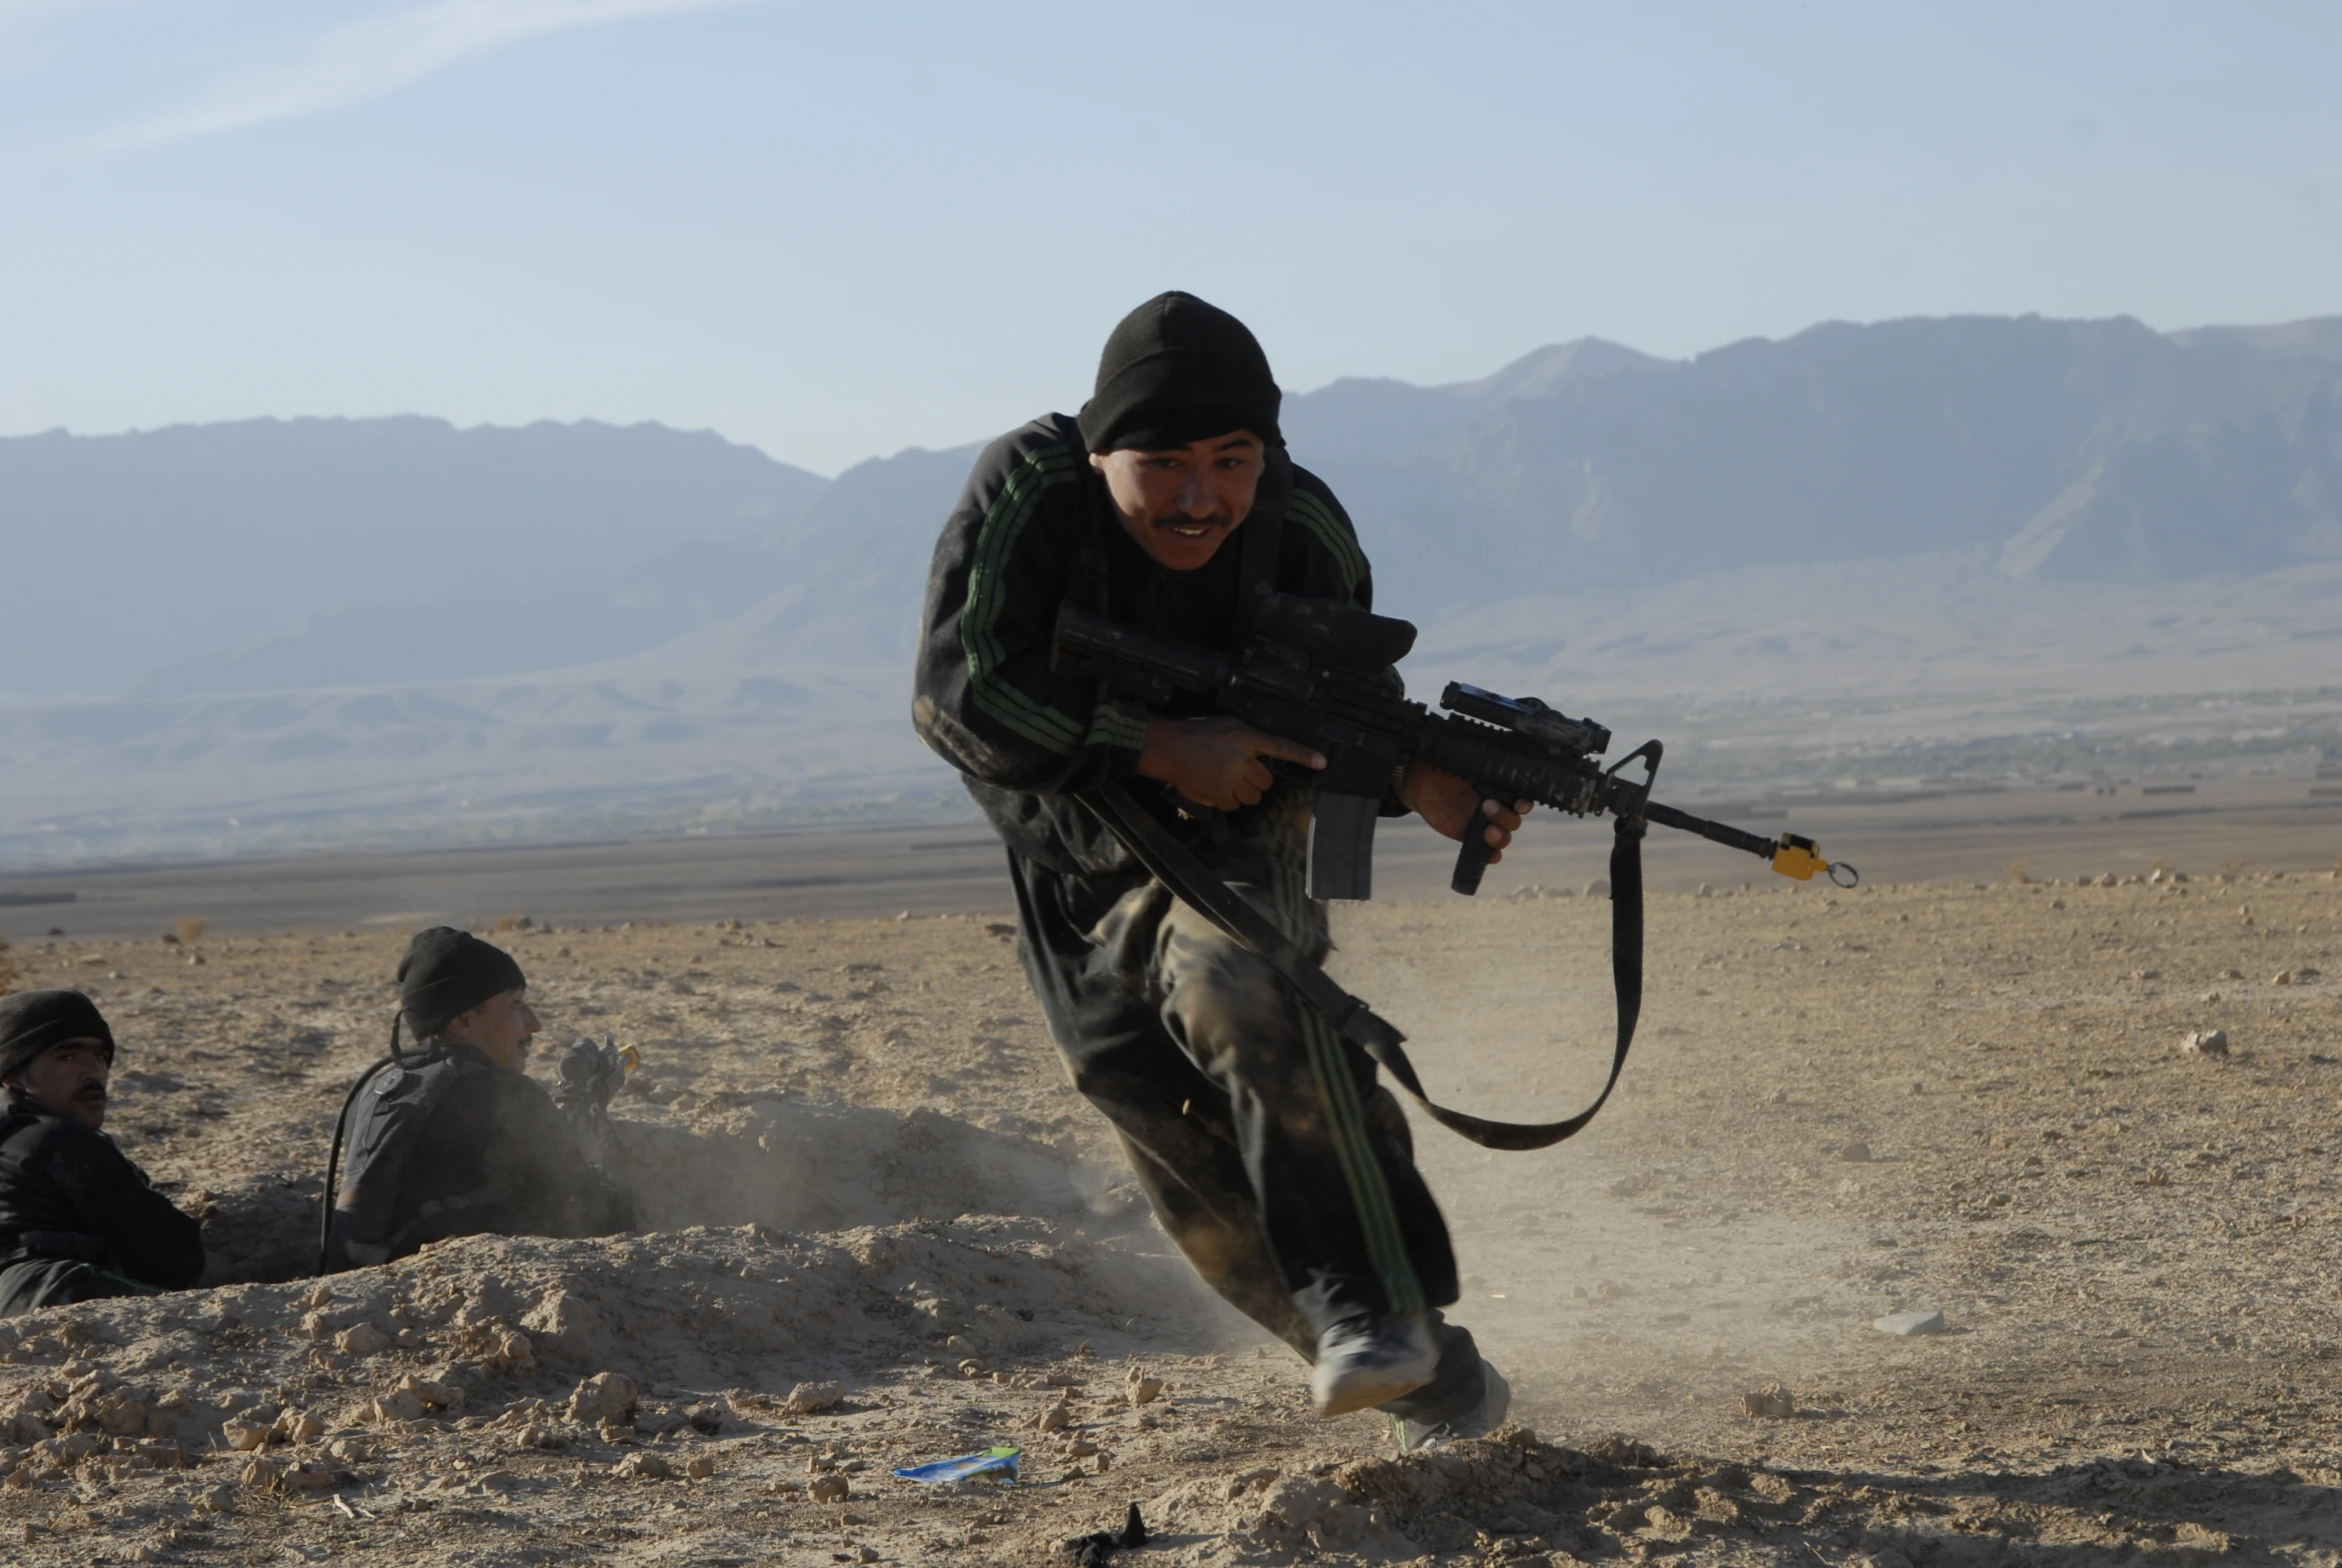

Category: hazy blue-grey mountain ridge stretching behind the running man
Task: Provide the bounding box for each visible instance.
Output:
[0,319,2342,864]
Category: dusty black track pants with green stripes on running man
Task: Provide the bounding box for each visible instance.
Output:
[1010,852,1480,1418]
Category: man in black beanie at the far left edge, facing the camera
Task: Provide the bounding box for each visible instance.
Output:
[0,990,204,1317]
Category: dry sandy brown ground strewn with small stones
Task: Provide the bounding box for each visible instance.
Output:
[0,866,2342,1568]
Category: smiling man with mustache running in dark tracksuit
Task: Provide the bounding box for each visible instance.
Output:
[914,293,1525,1448]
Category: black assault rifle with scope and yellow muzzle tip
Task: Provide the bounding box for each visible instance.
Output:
[1052,587,1858,899]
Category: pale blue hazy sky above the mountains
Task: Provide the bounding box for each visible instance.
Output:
[0,0,2342,472]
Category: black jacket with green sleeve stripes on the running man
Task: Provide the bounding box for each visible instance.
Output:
[911,414,1375,873]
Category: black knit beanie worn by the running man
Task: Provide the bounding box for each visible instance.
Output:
[1080,291,1283,451]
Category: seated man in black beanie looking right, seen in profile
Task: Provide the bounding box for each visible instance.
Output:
[319,927,634,1273]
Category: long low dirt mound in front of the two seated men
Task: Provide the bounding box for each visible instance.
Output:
[0,1217,1192,1441]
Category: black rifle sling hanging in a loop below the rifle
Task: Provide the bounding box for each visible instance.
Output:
[1080,784,1644,1150]
